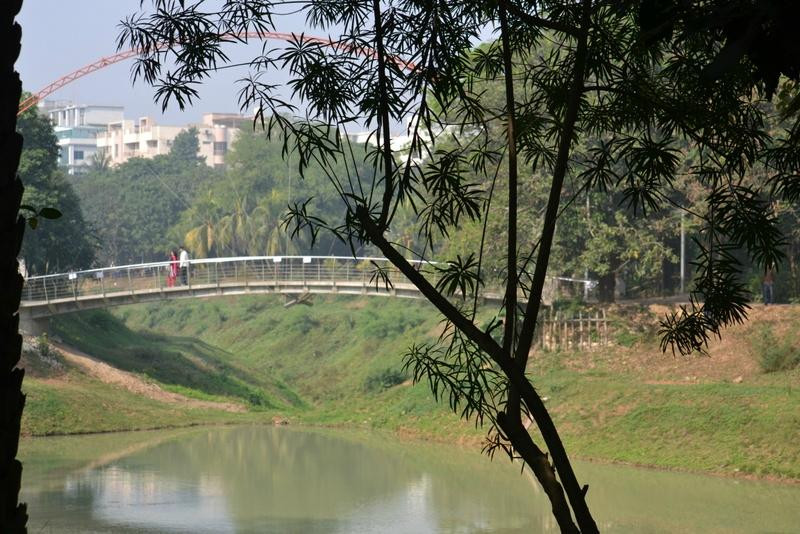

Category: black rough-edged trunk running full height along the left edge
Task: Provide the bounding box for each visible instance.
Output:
[0,0,28,533]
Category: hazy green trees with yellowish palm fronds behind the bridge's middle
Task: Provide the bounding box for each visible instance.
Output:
[170,130,368,257]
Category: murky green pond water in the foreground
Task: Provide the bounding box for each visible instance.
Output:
[17,426,800,534]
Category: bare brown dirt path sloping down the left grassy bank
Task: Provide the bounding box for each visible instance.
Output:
[53,343,246,412]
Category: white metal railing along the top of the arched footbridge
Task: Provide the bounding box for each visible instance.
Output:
[21,256,594,307]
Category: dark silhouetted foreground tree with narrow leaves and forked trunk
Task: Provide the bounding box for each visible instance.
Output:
[119,0,800,533]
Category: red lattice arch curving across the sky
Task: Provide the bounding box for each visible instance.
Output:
[17,32,414,115]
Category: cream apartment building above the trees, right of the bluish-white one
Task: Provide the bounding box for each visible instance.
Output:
[97,113,245,167]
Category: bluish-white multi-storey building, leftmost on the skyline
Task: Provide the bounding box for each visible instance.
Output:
[39,101,123,174]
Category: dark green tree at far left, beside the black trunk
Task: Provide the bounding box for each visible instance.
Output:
[17,109,94,274]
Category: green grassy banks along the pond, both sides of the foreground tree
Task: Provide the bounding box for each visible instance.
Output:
[24,297,800,478]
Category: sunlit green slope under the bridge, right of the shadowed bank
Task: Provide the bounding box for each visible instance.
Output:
[100,296,480,437]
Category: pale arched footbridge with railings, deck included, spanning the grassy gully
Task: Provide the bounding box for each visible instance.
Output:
[20,256,592,321]
